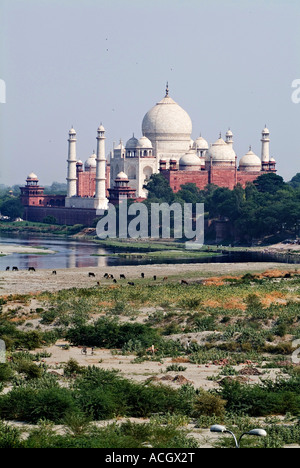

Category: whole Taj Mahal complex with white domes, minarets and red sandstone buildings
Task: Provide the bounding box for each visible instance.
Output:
[21,85,276,225]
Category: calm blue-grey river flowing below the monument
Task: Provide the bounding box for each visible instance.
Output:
[0,234,298,271]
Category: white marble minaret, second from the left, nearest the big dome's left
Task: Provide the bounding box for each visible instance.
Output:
[95,125,108,210]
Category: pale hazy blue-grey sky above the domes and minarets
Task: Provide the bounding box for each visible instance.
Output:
[0,0,300,185]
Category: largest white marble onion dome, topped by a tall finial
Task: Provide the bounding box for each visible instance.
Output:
[142,90,192,139]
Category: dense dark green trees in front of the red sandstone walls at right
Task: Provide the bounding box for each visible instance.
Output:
[146,173,300,245]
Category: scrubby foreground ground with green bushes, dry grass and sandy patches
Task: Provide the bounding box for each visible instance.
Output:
[0,270,300,448]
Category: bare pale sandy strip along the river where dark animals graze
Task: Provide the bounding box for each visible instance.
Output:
[0,262,300,296]
